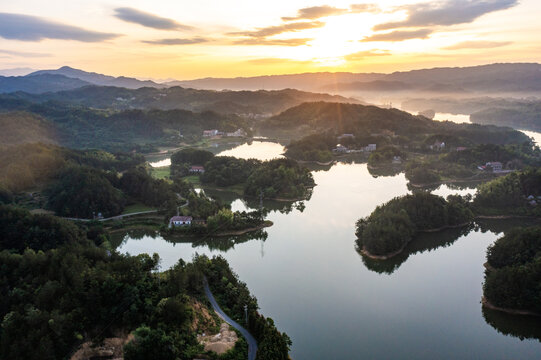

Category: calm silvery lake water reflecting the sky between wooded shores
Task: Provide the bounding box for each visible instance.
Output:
[119,143,541,360]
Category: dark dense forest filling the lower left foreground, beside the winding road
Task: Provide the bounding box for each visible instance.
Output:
[0,206,291,360]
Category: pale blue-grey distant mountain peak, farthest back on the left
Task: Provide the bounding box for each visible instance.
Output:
[28,66,165,89]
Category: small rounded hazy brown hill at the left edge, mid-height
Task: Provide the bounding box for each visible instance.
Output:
[0,112,57,145]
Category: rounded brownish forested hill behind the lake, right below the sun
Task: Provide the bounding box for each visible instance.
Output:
[262,102,529,144]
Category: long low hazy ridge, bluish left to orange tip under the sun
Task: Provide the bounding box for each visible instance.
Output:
[3,86,358,115]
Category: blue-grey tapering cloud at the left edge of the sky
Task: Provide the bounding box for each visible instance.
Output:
[0,13,119,42]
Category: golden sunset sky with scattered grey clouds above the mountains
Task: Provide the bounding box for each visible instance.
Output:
[0,0,541,80]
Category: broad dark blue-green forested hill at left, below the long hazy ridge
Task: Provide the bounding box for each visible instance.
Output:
[0,96,249,151]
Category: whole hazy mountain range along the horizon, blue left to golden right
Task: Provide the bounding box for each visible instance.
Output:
[0,63,541,94]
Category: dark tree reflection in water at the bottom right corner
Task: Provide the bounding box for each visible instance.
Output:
[483,307,541,341]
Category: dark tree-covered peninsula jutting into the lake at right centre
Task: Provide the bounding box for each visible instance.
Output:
[355,192,473,256]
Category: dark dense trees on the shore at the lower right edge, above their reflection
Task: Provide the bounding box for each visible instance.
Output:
[483,227,541,314]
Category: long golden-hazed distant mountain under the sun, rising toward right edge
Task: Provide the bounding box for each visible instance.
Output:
[172,63,541,93]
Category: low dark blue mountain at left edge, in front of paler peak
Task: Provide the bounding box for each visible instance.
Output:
[0,74,90,94]
